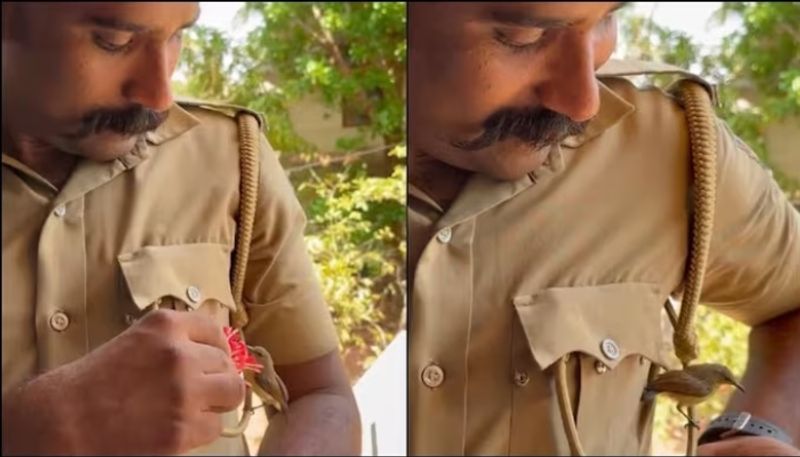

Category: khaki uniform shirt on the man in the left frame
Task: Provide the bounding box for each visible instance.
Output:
[2,101,337,455]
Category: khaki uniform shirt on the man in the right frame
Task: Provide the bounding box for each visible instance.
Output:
[409,64,800,455]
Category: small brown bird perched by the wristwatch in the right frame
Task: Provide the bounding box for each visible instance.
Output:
[642,363,744,428]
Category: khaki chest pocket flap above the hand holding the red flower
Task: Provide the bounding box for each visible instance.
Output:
[117,243,236,325]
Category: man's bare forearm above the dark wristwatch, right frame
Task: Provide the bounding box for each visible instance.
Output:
[727,311,800,445]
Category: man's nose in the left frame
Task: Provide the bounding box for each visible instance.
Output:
[123,47,174,112]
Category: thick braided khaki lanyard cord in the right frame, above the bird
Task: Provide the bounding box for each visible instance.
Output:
[555,80,717,456]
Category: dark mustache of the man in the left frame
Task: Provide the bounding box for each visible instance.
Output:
[67,105,168,139]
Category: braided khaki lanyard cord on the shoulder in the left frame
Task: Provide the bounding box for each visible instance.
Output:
[222,112,260,437]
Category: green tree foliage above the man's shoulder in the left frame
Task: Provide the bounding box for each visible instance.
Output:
[179,2,406,156]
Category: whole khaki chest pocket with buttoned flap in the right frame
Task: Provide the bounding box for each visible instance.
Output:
[512,283,669,455]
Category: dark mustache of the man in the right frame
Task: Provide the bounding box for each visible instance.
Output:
[451,108,589,151]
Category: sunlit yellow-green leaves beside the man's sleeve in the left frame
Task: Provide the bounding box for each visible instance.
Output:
[300,147,406,357]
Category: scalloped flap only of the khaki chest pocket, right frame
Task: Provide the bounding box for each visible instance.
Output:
[514,283,668,370]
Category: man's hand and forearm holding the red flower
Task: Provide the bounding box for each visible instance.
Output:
[3,310,244,455]
